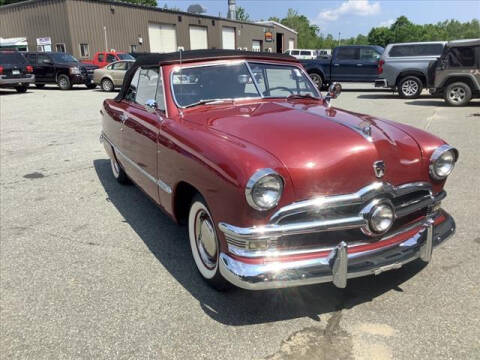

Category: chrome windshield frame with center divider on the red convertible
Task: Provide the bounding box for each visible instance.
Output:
[169,59,323,109]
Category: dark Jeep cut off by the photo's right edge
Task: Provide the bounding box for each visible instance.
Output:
[428,39,480,106]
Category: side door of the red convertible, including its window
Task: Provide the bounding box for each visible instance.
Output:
[122,67,165,202]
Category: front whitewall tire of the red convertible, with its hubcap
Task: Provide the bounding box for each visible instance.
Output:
[188,194,231,291]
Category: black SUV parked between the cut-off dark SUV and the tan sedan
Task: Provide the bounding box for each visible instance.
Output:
[24,52,98,90]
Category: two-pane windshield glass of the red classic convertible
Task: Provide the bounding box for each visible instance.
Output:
[172,62,320,107]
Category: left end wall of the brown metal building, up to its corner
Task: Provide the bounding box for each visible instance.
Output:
[0,0,72,52]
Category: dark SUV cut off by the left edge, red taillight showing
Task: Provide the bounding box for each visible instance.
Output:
[0,50,35,93]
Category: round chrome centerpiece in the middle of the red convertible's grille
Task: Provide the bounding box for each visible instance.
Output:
[362,200,395,236]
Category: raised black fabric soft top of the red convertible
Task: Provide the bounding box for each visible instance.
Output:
[115,49,298,101]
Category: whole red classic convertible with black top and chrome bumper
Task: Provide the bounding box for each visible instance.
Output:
[101,50,458,290]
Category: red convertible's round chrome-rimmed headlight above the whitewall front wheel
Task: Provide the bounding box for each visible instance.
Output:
[245,169,283,211]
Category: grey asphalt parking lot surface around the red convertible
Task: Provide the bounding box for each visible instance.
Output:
[0,84,480,360]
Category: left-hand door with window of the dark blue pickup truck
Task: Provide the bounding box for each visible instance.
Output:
[331,46,360,81]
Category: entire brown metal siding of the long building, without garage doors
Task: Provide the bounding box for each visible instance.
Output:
[0,0,297,58]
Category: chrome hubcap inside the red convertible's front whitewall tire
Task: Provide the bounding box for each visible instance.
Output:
[195,210,217,269]
